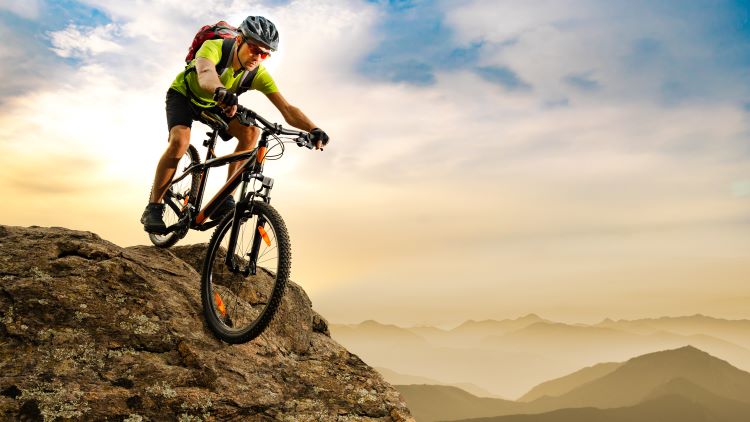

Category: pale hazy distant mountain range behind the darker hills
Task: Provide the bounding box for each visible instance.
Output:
[330,314,750,401]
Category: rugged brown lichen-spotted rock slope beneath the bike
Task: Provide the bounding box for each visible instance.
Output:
[0,226,413,421]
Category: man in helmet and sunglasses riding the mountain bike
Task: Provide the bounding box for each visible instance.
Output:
[141,16,328,234]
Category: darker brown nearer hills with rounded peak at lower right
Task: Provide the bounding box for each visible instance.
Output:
[396,346,750,422]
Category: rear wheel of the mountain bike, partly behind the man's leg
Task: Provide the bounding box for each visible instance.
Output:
[148,145,201,248]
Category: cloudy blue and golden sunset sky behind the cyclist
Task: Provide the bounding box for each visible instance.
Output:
[0,0,750,326]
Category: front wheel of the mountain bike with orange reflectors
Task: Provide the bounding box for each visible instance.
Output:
[201,202,292,344]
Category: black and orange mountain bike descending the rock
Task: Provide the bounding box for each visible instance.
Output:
[149,106,313,344]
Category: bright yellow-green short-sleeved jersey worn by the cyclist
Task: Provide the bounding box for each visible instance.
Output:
[171,39,279,108]
